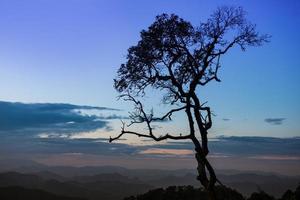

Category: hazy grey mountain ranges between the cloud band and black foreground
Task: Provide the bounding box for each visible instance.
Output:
[0,162,300,199]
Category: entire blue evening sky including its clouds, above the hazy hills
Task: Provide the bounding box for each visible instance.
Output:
[0,0,300,172]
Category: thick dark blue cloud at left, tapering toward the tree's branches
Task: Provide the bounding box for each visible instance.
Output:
[0,101,120,134]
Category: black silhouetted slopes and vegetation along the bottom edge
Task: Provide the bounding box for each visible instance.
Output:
[0,185,300,200]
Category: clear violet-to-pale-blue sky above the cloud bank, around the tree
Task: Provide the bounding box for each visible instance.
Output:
[0,0,300,173]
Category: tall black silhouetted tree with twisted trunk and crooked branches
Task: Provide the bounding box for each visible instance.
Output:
[110,7,269,200]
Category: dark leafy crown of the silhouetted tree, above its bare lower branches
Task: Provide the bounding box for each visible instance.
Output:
[114,7,269,103]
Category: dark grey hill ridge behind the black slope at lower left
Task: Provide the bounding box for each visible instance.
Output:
[0,172,152,200]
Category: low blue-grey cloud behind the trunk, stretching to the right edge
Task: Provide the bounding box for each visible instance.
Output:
[144,136,300,157]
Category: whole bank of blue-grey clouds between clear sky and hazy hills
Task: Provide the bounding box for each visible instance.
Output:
[0,102,300,173]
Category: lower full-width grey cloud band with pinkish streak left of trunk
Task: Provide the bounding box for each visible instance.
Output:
[0,127,300,163]
